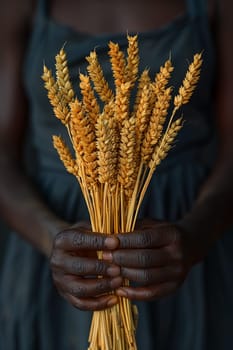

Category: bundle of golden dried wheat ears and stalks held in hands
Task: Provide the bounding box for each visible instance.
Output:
[42,36,202,350]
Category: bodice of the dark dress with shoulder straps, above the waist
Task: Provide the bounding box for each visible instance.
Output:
[25,0,215,180]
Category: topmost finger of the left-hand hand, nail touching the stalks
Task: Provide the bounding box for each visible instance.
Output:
[54,229,119,252]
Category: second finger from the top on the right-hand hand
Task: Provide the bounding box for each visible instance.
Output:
[110,247,174,268]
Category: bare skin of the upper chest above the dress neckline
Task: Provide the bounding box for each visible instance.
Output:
[50,0,214,34]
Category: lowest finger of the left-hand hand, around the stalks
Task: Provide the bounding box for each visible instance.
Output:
[64,294,118,311]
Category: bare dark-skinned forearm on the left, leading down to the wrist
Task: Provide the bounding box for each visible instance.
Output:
[0,156,67,256]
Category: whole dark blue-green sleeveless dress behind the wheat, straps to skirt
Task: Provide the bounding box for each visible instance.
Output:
[0,0,233,350]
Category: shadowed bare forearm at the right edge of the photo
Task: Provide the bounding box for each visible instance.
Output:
[179,154,233,246]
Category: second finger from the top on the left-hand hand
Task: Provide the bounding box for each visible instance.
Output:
[51,253,120,276]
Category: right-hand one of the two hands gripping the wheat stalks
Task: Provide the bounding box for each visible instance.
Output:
[103,221,196,300]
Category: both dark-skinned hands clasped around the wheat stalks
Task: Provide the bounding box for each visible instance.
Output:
[50,221,199,310]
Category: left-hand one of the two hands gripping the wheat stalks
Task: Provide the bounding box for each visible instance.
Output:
[50,223,123,310]
